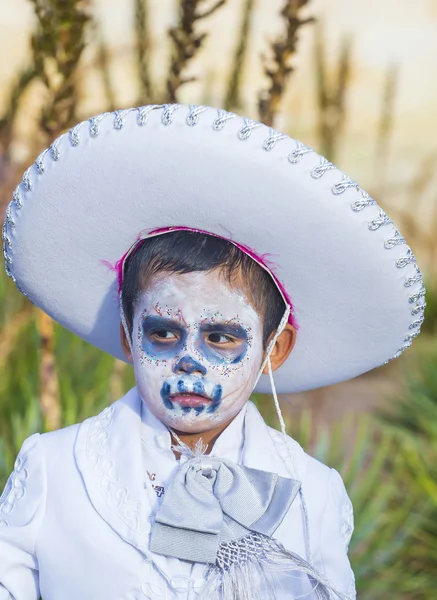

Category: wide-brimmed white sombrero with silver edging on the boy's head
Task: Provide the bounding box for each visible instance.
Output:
[3,104,425,392]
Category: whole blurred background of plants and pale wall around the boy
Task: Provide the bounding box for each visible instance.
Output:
[0,0,437,600]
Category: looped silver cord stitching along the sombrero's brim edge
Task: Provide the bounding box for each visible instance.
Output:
[2,104,426,364]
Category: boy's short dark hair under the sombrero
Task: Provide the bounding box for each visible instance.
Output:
[121,230,285,347]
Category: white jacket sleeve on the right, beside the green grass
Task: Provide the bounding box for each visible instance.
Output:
[320,469,356,600]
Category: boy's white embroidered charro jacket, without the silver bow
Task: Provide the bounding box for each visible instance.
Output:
[0,388,355,600]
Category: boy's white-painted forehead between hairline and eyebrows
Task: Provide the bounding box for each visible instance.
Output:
[137,270,259,319]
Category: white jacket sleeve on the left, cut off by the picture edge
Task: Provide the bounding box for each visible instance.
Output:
[0,433,46,600]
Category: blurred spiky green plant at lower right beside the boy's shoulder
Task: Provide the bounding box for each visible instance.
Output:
[247,396,437,600]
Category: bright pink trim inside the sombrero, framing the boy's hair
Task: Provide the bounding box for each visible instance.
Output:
[104,225,299,331]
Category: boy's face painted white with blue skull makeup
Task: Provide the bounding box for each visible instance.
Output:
[132,271,263,433]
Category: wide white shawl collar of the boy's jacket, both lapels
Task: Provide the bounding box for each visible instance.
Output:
[74,387,302,576]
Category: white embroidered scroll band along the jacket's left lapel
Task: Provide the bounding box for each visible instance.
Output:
[86,405,141,532]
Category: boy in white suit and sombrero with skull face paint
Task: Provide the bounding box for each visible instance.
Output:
[0,105,424,600]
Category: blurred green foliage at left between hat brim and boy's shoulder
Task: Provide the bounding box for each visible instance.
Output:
[0,270,135,480]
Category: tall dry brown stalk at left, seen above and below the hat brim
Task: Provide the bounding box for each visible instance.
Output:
[15,0,91,429]
